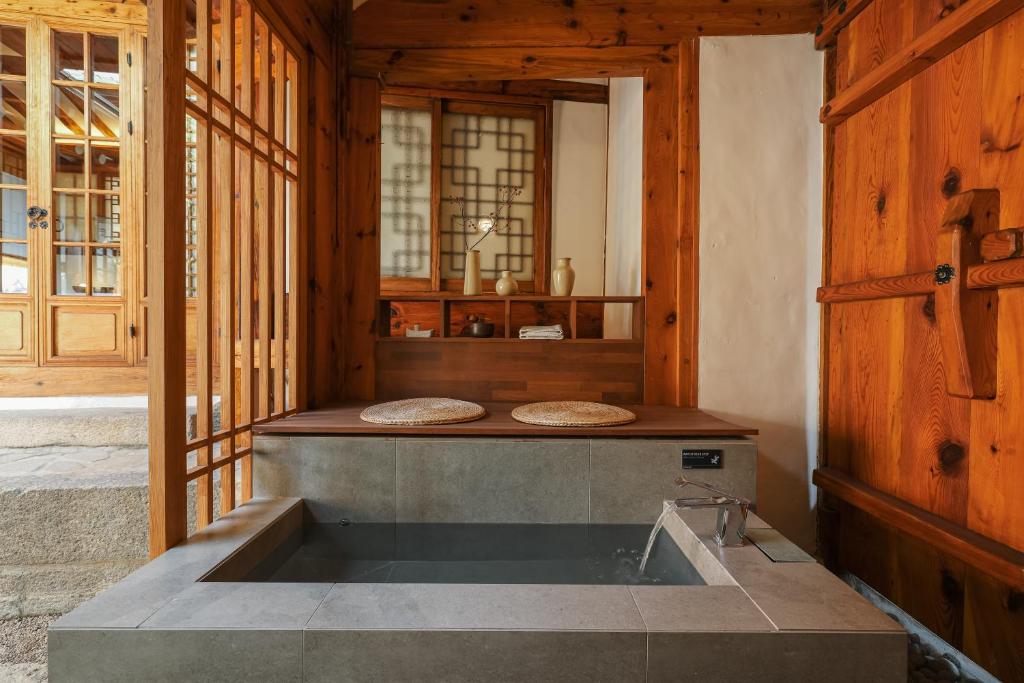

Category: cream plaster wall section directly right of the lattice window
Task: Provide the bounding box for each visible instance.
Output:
[548,100,608,296]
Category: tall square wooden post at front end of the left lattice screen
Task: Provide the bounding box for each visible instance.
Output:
[146,0,186,557]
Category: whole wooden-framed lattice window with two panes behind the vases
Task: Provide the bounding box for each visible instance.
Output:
[381,88,551,292]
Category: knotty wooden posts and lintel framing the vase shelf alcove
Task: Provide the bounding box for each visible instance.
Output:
[343,38,699,408]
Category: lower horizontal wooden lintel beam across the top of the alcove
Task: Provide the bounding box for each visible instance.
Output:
[351,45,679,83]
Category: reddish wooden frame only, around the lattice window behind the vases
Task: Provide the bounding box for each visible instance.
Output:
[377,87,554,295]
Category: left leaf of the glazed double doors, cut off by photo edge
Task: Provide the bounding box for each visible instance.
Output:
[0,22,37,364]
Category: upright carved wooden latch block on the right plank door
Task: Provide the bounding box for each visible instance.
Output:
[935,189,999,398]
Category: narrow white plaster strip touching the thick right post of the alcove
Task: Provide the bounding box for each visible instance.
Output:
[604,78,643,337]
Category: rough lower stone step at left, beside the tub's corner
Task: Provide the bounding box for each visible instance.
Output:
[0,446,219,622]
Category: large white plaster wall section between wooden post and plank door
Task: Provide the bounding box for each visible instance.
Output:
[698,36,822,549]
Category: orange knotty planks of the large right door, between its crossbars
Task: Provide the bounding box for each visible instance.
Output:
[823,0,1024,680]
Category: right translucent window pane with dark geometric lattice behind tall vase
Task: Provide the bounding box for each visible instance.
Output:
[440,114,536,281]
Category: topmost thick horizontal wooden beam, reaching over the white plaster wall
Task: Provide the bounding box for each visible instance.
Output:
[352,0,821,48]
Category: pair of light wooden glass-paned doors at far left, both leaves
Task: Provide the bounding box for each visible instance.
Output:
[0,12,142,366]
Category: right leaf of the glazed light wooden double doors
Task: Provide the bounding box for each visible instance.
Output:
[30,19,137,365]
